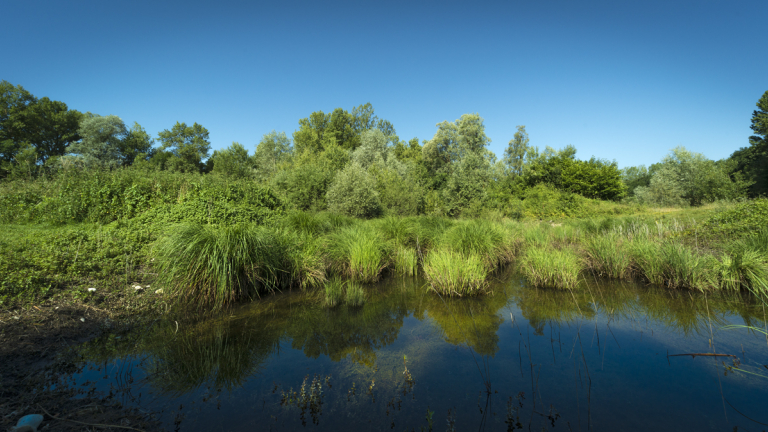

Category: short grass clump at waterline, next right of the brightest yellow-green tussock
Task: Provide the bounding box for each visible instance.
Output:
[520,247,583,289]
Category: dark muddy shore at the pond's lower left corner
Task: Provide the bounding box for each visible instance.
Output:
[0,290,164,431]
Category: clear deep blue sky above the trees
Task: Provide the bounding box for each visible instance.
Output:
[0,0,768,167]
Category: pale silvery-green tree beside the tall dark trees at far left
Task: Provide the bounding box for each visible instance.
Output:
[67,113,128,168]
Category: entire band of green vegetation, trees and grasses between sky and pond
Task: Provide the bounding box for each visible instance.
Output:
[0,81,768,309]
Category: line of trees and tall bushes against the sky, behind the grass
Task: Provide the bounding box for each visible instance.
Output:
[0,81,768,218]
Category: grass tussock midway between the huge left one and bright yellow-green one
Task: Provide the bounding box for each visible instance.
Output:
[328,224,386,283]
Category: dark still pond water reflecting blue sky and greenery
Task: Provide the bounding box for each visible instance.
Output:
[73,274,768,431]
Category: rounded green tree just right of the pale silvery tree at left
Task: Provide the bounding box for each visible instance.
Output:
[158,122,211,172]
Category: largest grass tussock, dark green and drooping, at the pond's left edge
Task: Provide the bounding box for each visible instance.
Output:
[156,225,290,309]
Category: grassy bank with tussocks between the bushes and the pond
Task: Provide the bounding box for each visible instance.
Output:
[0,191,768,309]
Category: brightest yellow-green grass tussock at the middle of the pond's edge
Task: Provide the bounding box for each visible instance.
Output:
[424,249,487,296]
